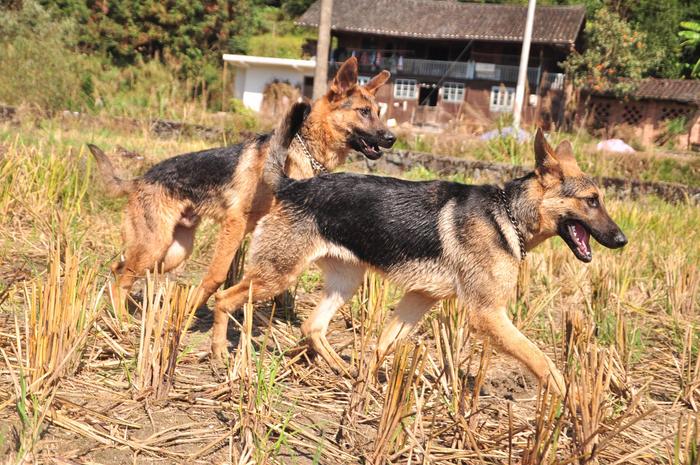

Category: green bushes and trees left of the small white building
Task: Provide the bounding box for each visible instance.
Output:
[0,0,312,115]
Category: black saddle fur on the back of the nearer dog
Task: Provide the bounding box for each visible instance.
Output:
[277,173,495,268]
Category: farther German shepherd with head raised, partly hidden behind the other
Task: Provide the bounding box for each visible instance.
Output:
[89,58,396,312]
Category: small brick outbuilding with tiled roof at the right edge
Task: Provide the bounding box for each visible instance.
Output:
[577,78,700,149]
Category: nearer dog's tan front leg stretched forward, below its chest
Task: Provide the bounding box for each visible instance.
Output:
[469,307,566,394]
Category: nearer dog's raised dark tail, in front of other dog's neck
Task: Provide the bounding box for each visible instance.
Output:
[263,102,311,192]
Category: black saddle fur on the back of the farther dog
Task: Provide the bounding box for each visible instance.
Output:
[143,134,270,202]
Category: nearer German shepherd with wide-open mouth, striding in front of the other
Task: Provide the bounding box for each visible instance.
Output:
[212,109,627,392]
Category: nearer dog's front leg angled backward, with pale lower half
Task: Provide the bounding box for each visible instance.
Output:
[373,292,437,368]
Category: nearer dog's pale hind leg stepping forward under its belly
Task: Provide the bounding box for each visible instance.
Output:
[301,258,365,375]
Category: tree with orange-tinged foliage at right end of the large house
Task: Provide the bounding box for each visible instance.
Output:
[562,8,659,95]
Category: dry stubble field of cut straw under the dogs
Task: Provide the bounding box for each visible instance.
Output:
[0,113,700,465]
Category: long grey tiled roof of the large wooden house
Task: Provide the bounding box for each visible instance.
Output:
[297,0,585,44]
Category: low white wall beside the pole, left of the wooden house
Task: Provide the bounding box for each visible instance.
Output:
[233,64,313,111]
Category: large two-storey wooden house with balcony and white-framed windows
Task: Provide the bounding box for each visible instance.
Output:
[297,0,585,126]
